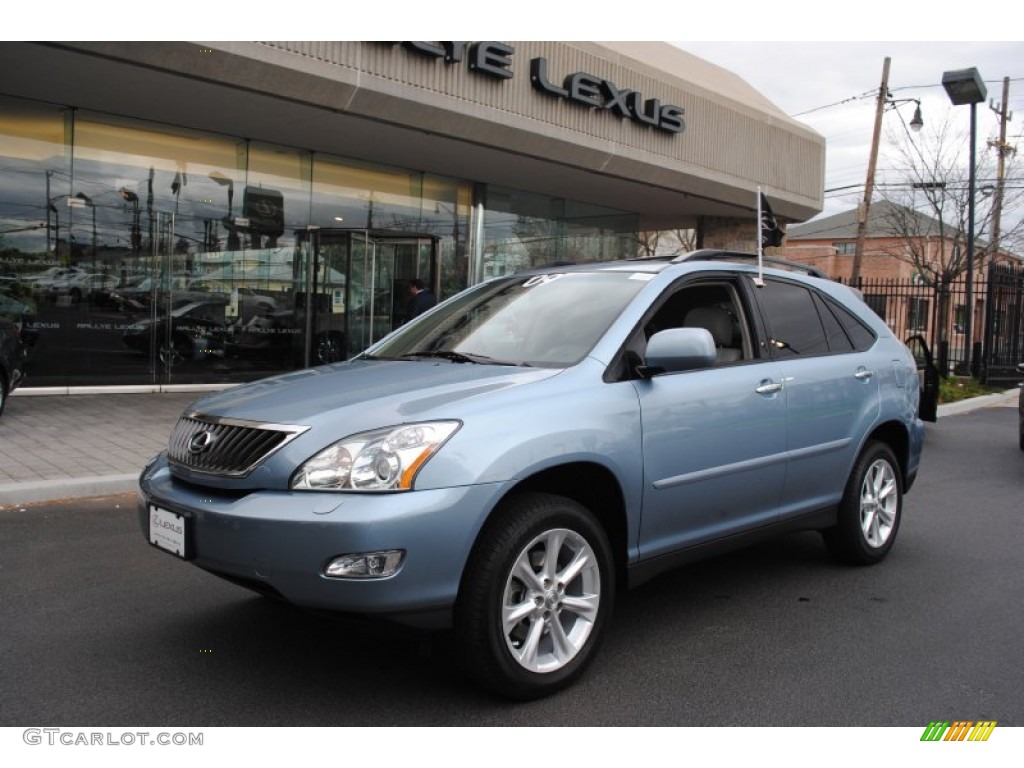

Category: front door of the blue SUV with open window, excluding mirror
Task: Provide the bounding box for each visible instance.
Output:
[634,281,786,558]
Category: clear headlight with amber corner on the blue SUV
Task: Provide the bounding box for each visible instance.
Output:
[291,421,459,490]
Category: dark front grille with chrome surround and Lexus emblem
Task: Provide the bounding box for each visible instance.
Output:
[167,413,309,477]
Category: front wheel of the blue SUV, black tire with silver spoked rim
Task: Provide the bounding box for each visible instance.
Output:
[455,494,615,700]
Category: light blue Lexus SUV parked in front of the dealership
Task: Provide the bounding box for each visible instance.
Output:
[139,256,924,698]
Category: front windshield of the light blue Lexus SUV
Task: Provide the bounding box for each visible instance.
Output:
[367,271,649,368]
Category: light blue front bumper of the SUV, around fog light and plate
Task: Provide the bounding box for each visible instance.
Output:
[138,455,499,626]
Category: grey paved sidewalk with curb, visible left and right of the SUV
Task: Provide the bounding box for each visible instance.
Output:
[0,389,1018,510]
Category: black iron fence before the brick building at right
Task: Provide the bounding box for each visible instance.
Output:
[839,264,1024,386]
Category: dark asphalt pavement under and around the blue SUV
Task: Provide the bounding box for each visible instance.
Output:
[0,403,1024,728]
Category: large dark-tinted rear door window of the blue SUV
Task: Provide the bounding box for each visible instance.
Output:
[755,280,829,357]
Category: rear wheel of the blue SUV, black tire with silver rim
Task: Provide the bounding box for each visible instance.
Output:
[822,441,903,565]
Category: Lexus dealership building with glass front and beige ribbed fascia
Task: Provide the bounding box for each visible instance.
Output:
[0,41,824,391]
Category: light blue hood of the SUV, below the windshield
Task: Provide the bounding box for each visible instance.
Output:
[188,360,561,427]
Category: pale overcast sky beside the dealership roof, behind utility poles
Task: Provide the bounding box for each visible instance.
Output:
[673,39,1024,222]
